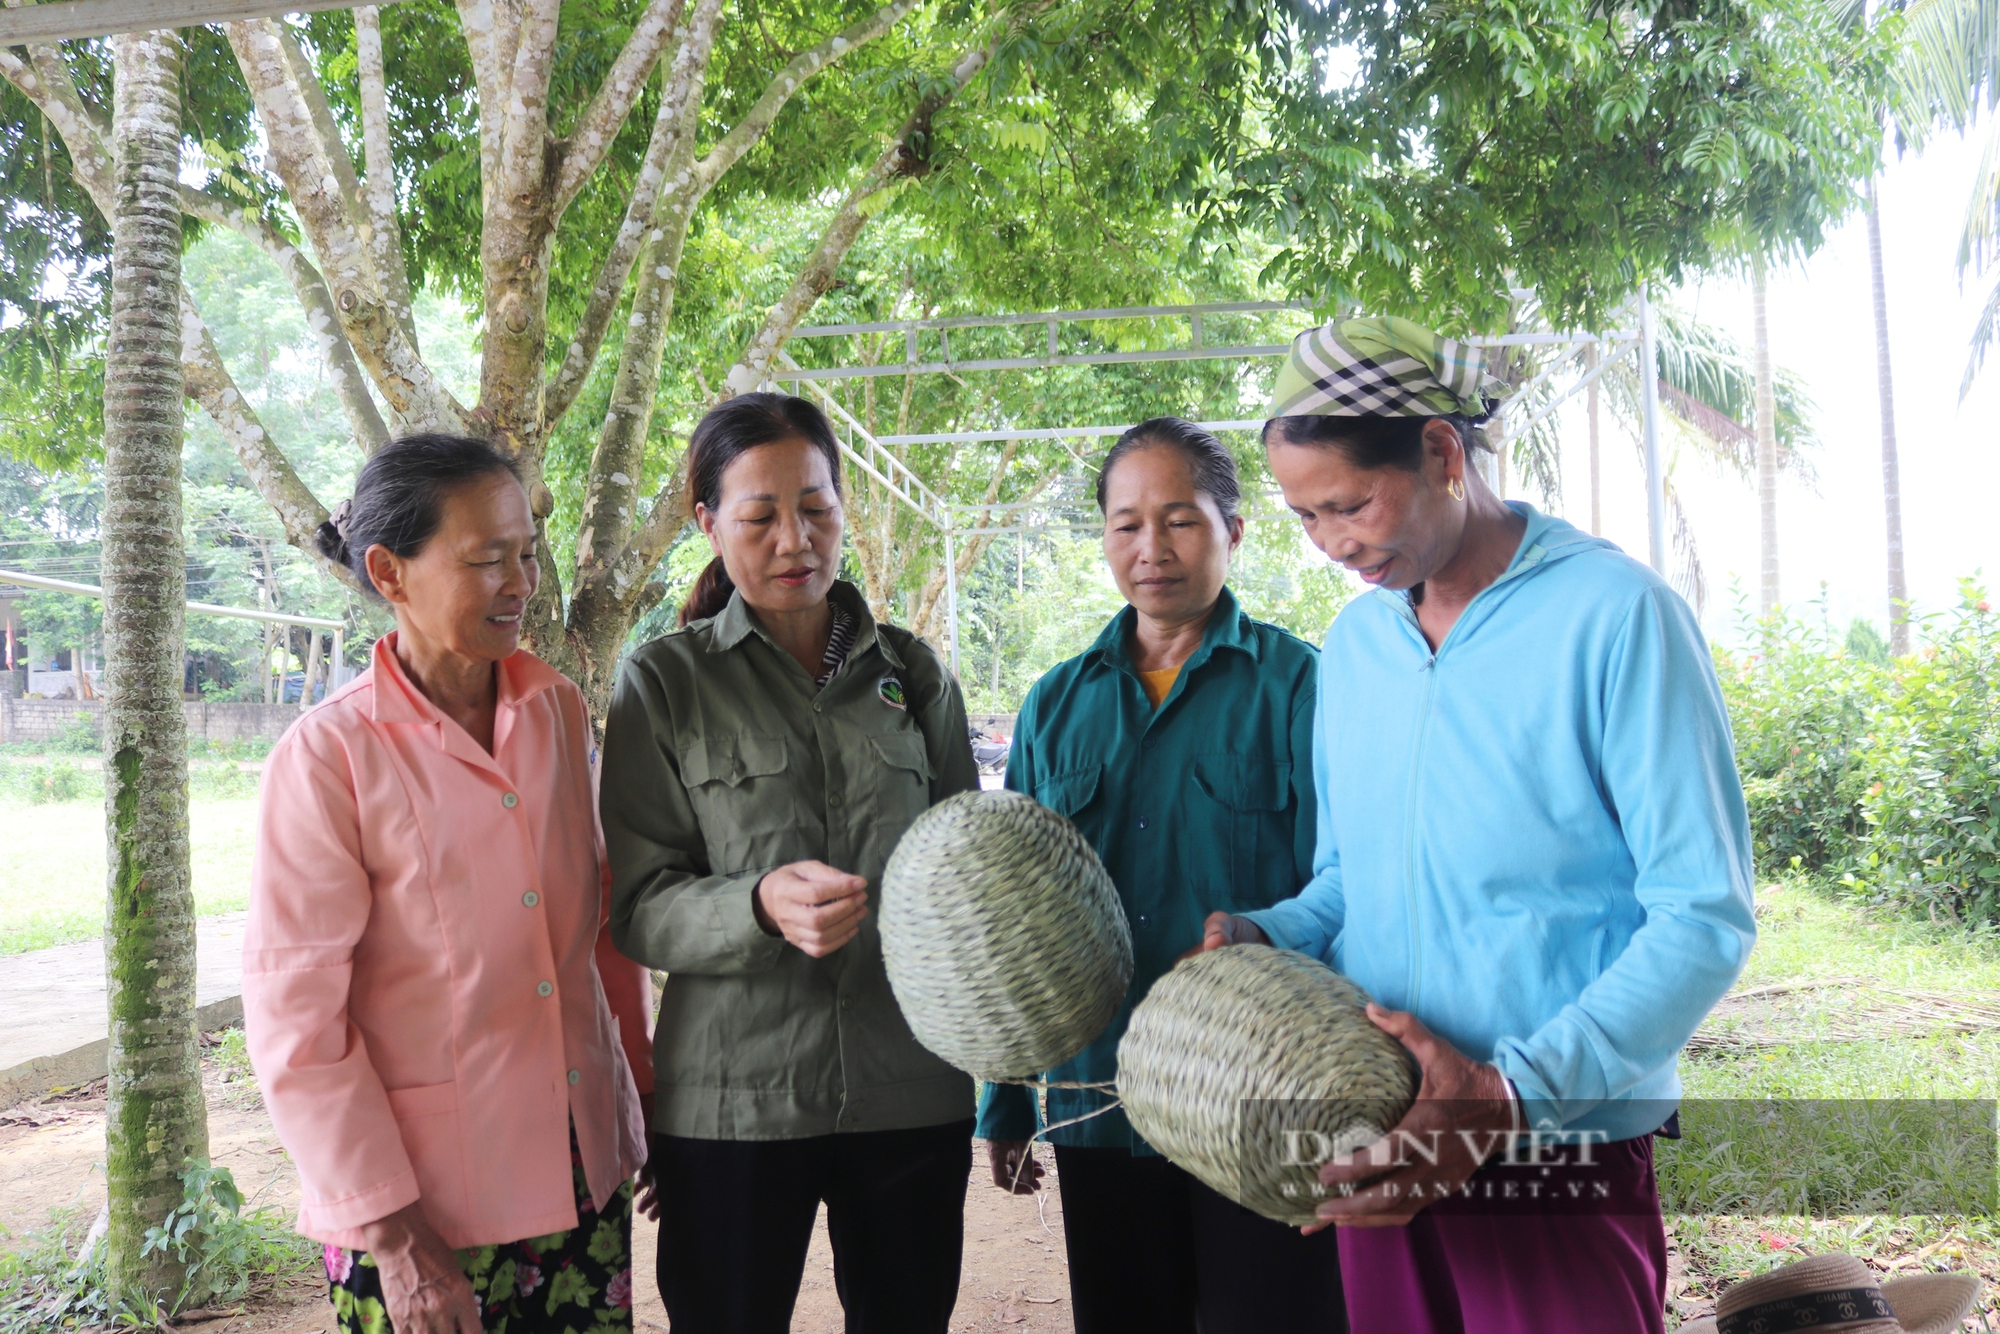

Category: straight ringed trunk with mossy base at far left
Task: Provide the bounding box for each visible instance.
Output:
[102,32,208,1306]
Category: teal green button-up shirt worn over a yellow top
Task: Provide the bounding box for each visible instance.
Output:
[978,588,1318,1154]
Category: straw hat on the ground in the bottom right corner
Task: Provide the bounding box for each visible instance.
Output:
[1680,1256,1980,1334]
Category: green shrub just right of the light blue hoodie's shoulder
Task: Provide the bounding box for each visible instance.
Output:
[1716,606,1880,876]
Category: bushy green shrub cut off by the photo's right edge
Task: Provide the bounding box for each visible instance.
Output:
[1846,580,2000,922]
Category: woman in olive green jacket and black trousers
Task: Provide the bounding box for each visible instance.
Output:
[602,394,978,1334]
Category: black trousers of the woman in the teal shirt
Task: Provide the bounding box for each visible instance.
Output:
[1056,1144,1348,1334]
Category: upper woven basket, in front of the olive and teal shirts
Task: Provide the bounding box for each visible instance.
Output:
[882,792,1132,1080]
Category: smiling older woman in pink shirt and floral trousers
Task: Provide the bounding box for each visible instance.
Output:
[244,436,652,1334]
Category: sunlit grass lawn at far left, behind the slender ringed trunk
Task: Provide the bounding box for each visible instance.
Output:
[0,758,256,954]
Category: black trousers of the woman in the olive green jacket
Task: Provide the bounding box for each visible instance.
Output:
[652,1120,972,1334]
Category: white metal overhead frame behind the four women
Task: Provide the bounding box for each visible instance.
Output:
[770,286,1666,674]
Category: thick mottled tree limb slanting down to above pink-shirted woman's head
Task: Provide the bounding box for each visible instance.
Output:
[228,18,466,430]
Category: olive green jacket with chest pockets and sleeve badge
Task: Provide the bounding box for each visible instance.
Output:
[600,584,978,1140]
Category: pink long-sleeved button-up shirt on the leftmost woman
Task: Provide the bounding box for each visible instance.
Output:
[244,634,652,1248]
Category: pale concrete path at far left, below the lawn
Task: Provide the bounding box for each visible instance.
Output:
[0,912,246,1106]
